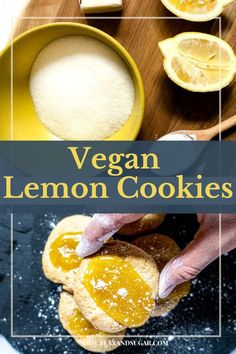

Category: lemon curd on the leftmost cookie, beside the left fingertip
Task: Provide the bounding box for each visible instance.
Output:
[49,232,82,271]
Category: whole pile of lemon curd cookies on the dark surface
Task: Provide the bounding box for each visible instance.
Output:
[43,214,189,352]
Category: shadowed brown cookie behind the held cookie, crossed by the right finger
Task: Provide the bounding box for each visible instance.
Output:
[133,234,190,317]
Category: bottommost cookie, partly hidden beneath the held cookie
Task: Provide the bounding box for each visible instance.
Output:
[58,292,125,353]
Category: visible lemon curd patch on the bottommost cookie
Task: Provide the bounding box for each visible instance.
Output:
[68,308,106,336]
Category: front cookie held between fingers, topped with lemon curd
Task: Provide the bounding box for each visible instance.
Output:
[74,241,159,333]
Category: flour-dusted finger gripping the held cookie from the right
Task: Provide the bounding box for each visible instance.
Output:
[159,214,236,298]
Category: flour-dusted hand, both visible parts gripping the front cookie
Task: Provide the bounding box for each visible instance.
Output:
[77,214,236,298]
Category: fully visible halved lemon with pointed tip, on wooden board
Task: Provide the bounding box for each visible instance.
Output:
[159,32,236,92]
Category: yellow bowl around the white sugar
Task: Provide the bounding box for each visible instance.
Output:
[0,22,144,140]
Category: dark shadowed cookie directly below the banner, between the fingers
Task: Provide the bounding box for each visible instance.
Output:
[118,214,165,236]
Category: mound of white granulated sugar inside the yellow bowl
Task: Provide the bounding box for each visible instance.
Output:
[30,35,135,140]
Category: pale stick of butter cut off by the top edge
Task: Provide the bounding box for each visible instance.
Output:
[80,0,123,14]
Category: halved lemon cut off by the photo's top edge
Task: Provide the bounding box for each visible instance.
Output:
[161,0,235,22]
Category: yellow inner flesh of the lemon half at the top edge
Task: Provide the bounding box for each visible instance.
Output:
[170,0,217,15]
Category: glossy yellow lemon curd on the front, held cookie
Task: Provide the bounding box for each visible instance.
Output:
[83,255,155,327]
